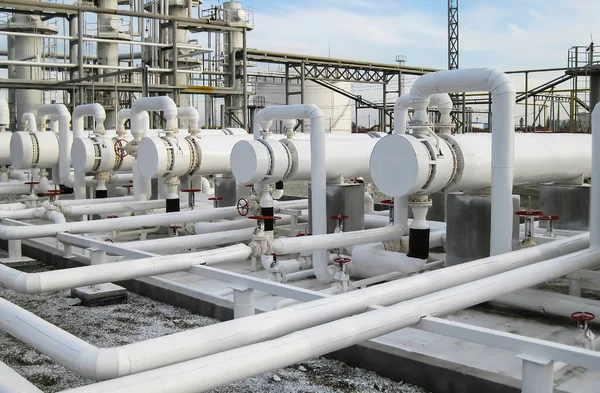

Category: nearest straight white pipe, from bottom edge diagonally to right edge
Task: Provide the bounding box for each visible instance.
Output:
[59,249,600,393]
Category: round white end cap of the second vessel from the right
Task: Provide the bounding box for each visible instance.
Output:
[231,140,271,184]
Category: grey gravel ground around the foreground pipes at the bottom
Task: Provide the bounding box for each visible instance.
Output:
[0,264,427,393]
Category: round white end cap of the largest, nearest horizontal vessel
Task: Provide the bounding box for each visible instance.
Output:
[371,135,429,197]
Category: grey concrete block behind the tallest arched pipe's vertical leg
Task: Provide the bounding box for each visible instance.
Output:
[446,194,520,266]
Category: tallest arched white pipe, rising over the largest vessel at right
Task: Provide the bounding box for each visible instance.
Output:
[410,68,515,255]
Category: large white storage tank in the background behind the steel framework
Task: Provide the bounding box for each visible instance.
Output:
[256,80,352,133]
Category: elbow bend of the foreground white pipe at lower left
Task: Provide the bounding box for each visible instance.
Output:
[77,347,131,381]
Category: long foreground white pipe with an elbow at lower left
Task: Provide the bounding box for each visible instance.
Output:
[0,233,588,382]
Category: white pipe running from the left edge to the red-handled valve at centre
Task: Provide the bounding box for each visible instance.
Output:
[0,244,251,294]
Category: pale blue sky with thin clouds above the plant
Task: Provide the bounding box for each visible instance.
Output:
[204,0,600,126]
